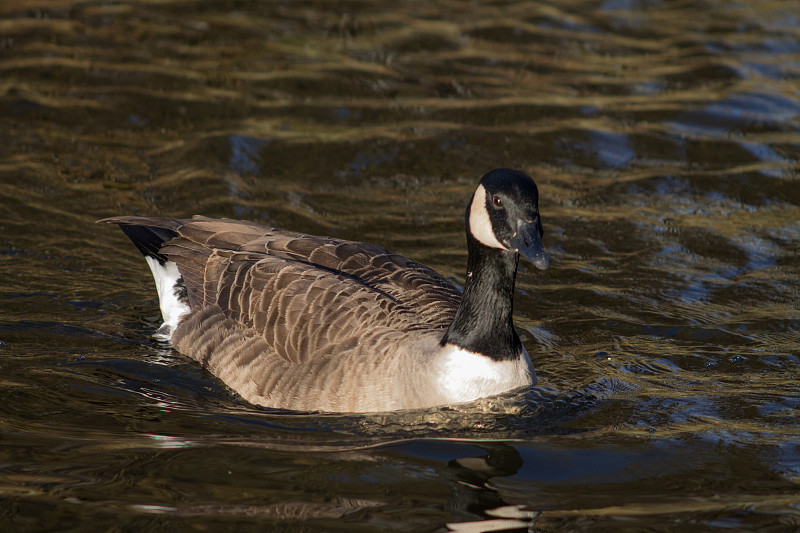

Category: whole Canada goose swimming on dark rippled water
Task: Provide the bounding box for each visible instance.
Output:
[100,169,550,412]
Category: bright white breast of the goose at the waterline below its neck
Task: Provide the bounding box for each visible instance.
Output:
[435,344,536,403]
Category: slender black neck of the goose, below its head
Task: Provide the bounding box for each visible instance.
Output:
[442,232,522,361]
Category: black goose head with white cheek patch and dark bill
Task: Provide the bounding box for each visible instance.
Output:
[466,168,550,270]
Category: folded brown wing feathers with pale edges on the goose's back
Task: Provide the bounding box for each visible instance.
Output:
[147,218,460,363]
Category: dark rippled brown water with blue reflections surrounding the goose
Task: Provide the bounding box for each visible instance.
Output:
[0,0,800,532]
